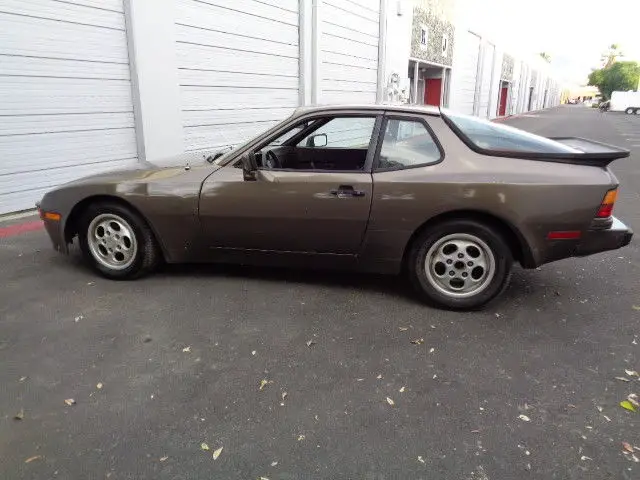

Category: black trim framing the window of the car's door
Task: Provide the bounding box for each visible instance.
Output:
[249,110,384,174]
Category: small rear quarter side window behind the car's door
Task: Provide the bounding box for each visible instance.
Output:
[377,118,442,170]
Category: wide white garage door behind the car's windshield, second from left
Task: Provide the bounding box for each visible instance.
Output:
[176,0,299,151]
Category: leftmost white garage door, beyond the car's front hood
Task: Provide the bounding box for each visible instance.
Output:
[0,0,137,214]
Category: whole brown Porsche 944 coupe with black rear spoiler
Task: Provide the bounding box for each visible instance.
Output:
[39,105,633,309]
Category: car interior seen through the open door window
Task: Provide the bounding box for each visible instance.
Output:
[256,117,376,171]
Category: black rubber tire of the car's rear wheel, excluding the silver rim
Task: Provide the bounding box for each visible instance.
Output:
[407,219,513,310]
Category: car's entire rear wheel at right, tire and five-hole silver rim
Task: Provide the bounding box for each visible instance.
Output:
[407,220,513,310]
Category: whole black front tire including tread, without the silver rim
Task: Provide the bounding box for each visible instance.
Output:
[78,202,161,280]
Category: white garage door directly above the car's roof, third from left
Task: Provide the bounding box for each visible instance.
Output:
[320,0,380,104]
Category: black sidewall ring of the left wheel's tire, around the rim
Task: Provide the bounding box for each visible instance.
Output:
[78,204,148,280]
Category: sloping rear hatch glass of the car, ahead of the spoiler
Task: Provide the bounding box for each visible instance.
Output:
[443,110,579,153]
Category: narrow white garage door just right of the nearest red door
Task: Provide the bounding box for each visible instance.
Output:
[451,32,480,115]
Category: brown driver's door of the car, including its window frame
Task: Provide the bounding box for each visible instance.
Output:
[199,113,381,255]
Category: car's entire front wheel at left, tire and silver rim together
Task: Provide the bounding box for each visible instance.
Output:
[78,202,160,280]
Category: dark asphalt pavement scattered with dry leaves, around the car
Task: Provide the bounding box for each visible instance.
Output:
[0,107,640,480]
